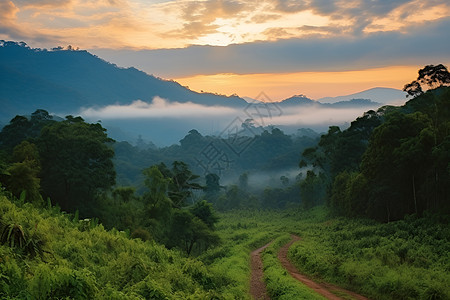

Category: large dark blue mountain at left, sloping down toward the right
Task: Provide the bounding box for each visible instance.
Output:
[0,41,247,120]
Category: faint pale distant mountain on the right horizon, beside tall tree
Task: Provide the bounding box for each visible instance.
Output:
[318,87,406,104]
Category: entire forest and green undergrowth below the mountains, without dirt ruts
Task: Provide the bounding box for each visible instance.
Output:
[0,65,450,299]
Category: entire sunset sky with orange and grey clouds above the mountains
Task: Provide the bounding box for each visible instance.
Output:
[0,0,450,100]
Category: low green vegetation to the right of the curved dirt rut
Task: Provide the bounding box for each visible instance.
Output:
[289,211,450,299]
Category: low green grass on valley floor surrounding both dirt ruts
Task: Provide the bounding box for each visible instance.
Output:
[212,206,450,299]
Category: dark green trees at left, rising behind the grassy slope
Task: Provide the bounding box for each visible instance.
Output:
[0,110,218,255]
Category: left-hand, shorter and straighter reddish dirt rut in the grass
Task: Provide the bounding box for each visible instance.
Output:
[250,242,272,300]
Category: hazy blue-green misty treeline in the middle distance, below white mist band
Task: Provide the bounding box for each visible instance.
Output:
[113,125,320,191]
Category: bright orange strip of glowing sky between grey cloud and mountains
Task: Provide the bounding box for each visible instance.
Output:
[174,66,421,101]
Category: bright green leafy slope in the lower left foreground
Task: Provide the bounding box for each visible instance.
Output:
[0,195,242,299]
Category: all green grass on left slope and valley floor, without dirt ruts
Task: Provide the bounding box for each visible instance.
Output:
[0,195,450,299]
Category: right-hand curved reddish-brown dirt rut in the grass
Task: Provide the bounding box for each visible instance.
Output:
[276,235,368,300]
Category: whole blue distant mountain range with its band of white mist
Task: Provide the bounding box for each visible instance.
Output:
[0,40,406,145]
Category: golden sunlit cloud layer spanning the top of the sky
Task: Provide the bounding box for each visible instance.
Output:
[0,0,450,49]
